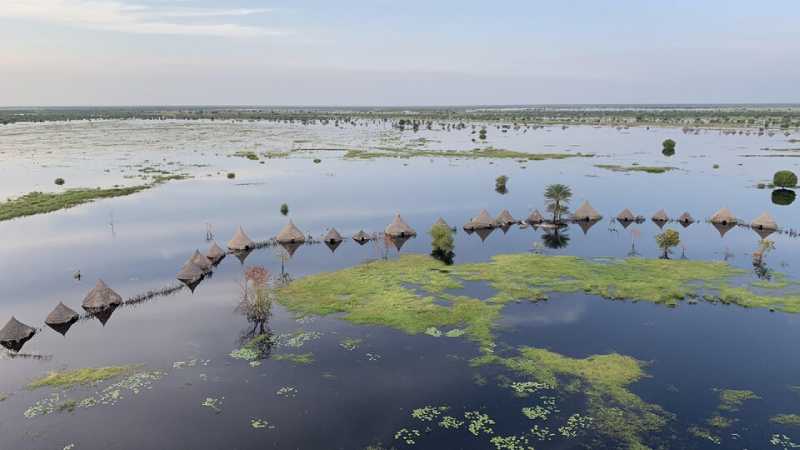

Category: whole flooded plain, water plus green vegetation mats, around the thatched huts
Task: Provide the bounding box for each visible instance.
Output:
[0,118,800,449]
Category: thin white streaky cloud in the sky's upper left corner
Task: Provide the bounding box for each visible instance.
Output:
[0,0,286,37]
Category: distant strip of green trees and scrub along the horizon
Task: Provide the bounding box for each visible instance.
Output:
[0,105,800,132]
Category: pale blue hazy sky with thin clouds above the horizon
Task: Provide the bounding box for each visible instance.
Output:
[0,0,800,106]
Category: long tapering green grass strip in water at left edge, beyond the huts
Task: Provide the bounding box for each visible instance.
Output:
[0,185,153,222]
